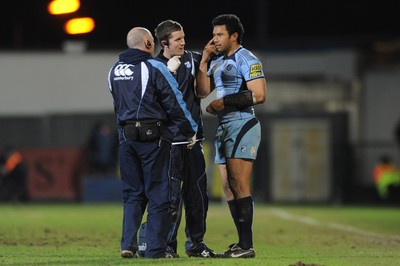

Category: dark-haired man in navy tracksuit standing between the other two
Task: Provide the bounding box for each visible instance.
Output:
[155,20,215,258]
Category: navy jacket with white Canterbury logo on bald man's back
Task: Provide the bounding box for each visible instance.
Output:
[108,49,198,142]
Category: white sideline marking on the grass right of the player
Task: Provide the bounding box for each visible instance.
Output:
[271,209,400,241]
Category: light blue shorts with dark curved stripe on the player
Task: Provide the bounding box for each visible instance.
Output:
[214,117,261,164]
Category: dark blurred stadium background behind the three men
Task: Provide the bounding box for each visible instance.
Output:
[0,0,400,204]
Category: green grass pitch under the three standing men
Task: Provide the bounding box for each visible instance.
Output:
[0,203,400,266]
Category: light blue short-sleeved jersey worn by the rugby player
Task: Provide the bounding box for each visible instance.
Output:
[207,47,264,122]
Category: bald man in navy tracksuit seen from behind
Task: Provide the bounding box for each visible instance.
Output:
[108,27,198,258]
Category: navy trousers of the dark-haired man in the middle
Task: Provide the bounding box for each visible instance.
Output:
[168,142,208,252]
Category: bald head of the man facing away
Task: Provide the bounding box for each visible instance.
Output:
[126,27,154,55]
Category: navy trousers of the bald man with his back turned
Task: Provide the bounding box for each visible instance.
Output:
[119,140,171,258]
